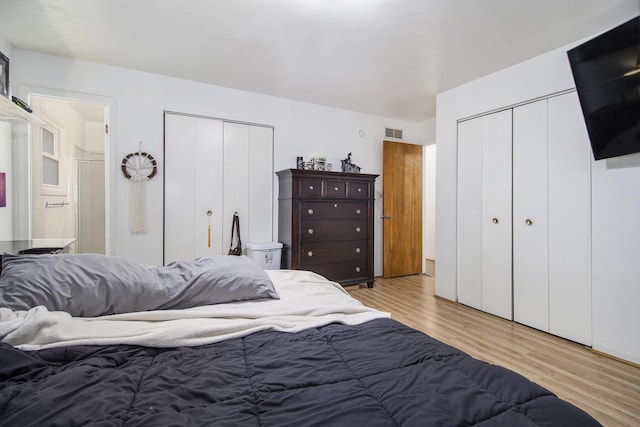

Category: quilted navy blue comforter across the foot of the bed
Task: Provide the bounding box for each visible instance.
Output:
[0,319,599,427]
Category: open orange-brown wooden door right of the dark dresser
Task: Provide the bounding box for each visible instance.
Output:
[382,141,423,277]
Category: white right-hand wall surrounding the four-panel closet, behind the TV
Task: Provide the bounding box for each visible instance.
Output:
[436,11,640,363]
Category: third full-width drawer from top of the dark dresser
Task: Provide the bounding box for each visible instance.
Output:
[298,240,369,268]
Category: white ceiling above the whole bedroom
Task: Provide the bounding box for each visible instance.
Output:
[0,0,640,122]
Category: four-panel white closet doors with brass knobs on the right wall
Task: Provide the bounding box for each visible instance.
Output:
[458,93,591,345]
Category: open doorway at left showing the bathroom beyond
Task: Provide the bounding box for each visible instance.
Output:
[29,95,109,254]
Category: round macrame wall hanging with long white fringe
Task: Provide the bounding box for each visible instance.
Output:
[122,141,158,234]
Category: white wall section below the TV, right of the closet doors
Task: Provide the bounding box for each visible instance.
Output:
[591,153,640,363]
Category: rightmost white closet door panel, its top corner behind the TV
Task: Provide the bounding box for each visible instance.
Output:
[549,92,592,345]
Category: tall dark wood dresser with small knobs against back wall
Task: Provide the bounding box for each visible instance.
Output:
[277,169,378,287]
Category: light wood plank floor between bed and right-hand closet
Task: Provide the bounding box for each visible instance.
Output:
[346,275,640,427]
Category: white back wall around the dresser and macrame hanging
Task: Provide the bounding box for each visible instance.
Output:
[12,50,416,274]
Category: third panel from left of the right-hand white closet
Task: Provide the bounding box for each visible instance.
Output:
[513,99,549,331]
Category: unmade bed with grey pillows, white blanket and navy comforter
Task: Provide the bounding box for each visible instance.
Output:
[0,254,599,426]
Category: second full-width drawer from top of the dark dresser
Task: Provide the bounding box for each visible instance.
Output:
[300,219,369,243]
